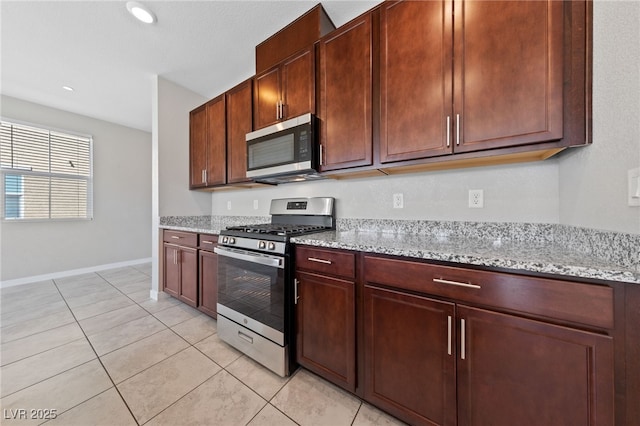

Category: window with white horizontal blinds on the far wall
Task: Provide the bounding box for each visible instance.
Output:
[0,121,93,220]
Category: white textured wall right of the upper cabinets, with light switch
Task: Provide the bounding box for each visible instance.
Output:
[559,1,640,234]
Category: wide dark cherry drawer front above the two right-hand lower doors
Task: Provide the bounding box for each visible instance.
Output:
[364,256,613,329]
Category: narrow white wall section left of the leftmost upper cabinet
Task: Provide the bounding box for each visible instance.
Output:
[157,77,211,216]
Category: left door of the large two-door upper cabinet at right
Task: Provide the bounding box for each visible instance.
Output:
[380,1,453,163]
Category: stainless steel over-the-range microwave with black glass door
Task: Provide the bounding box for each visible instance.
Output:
[246,114,322,184]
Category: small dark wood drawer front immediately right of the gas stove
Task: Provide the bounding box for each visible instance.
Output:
[296,247,356,279]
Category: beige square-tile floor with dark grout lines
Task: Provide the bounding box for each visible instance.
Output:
[0,264,401,426]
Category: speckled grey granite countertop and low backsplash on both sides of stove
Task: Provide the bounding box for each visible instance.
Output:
[160,216,640,284]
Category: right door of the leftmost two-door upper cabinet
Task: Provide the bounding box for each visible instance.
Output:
[207,95,227,185]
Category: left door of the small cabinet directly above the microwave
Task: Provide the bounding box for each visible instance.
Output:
[253,66,282,129]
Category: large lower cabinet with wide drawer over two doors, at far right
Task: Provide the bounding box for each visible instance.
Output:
[363,256,614,426]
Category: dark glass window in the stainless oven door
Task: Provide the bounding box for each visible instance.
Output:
[218,256,285,333]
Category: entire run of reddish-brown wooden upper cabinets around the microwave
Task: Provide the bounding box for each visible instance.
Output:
[190,0,593,188]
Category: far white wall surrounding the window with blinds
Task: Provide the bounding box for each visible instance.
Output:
[0,96,151,281]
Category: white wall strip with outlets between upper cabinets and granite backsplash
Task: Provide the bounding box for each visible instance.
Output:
[212,160,558,223]
